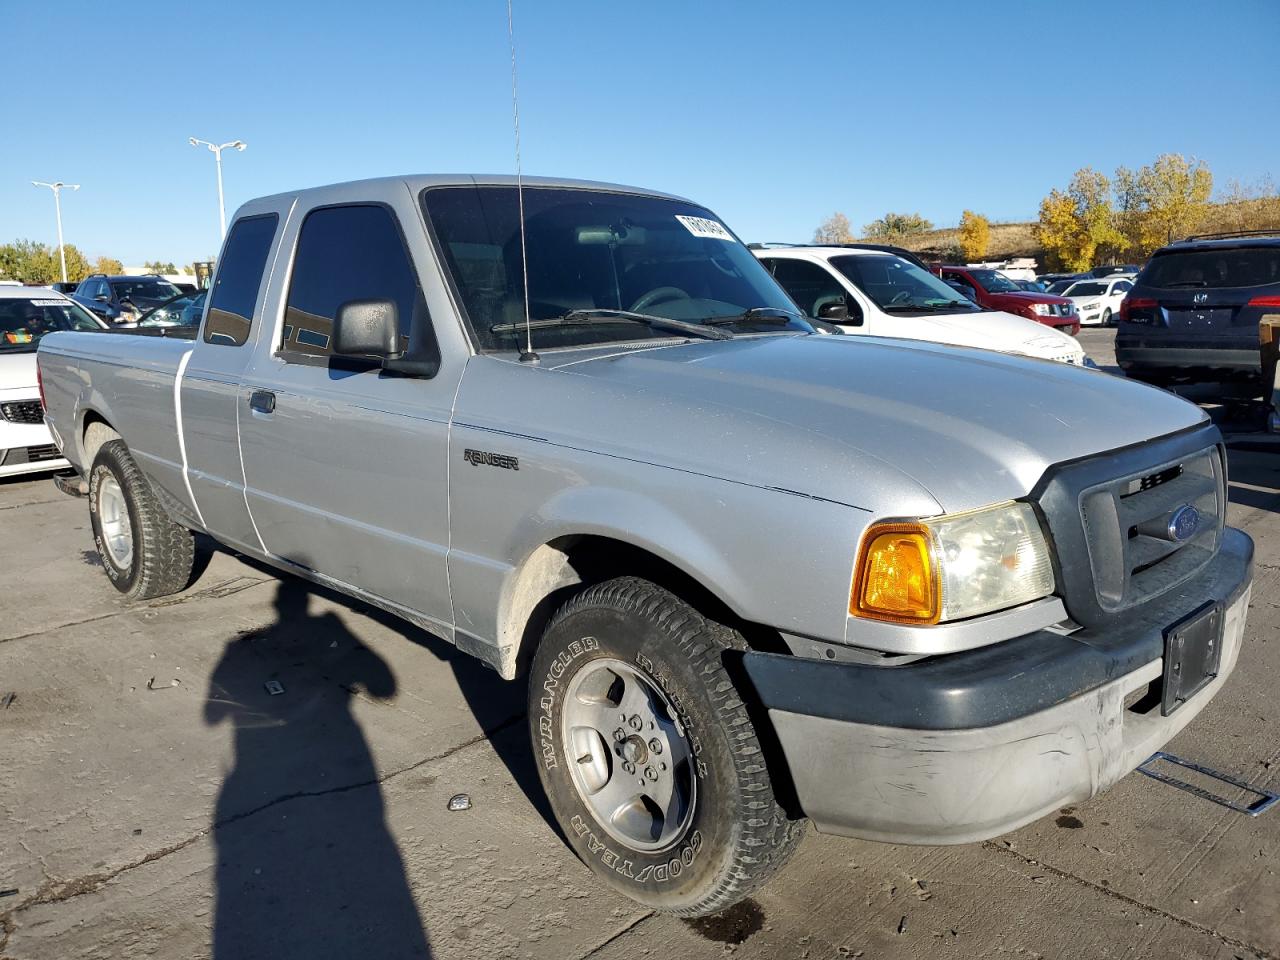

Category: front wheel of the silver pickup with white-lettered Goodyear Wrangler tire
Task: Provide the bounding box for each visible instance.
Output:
[529,577,804,916]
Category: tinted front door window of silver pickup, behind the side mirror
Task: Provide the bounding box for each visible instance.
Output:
[279,205,430,360]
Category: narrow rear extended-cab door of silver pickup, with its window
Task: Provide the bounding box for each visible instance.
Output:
[178,212,280,550]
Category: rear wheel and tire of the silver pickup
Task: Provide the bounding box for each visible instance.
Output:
[88,440,196,600]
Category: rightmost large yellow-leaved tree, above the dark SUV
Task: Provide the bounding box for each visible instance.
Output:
[1116,154,1213,256]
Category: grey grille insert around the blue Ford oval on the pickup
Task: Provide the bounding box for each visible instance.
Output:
[1080,447,1226,613]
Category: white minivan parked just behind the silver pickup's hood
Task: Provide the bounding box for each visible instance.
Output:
[755,244,1084,364]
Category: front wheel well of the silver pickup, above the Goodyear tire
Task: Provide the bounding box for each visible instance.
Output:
[500,535,787,676]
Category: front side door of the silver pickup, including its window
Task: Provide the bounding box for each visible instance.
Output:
[239,198,465,636]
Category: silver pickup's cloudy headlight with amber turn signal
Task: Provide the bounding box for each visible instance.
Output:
[849,502,1053,623]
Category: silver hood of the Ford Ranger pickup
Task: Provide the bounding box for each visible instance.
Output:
[454,335,1206,522]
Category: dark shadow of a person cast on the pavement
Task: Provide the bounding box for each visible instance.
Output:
[205,579,431,960]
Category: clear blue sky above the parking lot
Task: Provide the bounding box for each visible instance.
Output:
[0,0,1280,264]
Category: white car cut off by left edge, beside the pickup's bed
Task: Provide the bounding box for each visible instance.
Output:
[0,285,106,476]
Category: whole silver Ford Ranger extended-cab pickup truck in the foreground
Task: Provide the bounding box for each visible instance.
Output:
[38,177,1253,916]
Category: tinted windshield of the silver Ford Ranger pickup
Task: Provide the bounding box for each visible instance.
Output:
[422,186,813,351]
